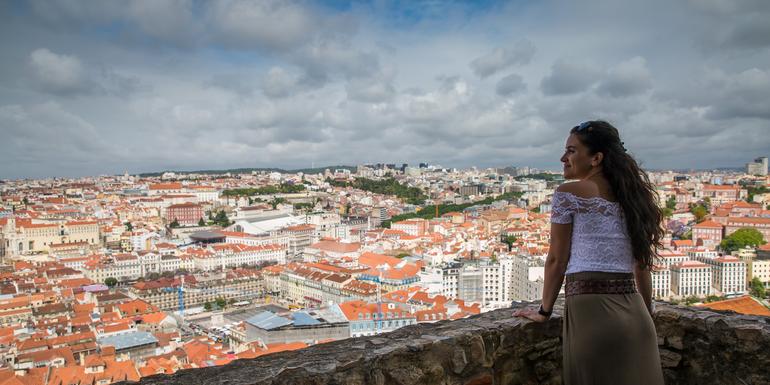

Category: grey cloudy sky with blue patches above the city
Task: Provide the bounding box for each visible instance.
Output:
[0,0,770,178]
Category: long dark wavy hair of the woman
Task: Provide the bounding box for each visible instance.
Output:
[570,120,664,269]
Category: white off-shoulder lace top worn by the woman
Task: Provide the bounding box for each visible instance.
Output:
[551,191,634,274]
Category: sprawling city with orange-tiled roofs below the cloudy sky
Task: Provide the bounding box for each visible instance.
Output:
[0,157,770,384]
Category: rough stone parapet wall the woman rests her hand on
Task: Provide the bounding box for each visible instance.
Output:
[117,305,770,385]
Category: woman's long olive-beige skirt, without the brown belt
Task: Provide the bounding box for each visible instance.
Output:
[563,272,663,385]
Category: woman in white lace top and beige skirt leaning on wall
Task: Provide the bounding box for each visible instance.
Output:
[514,121,663,385]
